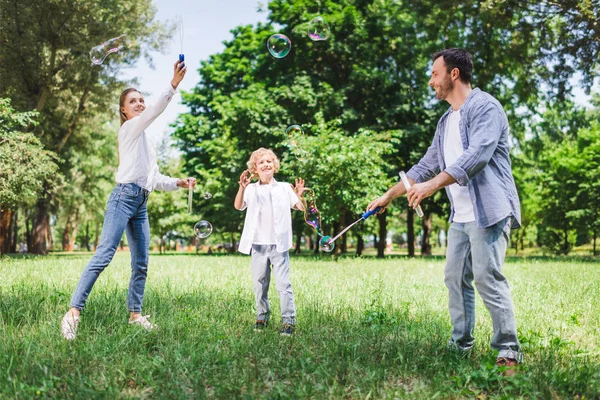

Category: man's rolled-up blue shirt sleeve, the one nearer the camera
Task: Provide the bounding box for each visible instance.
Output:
[445,101,505,186]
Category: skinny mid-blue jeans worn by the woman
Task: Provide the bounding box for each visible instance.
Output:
[71,183,150,313]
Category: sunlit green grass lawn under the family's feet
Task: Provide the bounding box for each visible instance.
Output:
[0,253,600,399]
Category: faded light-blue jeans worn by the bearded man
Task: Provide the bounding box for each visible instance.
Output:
[444,217,523,361]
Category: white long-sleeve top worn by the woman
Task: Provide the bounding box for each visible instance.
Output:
[116,85,178,191]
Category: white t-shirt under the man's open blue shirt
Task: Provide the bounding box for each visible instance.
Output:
[444,109,475,223]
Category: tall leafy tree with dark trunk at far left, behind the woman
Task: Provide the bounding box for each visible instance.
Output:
[0,0,175,254]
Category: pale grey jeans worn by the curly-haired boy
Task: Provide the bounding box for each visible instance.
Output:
[252,244,296,325]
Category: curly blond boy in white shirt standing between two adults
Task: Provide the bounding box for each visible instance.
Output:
[234,147,304,336]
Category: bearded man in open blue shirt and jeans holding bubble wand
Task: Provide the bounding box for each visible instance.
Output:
[368,49,523,371]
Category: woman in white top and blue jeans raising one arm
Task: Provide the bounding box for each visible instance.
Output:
[61,61,196,340]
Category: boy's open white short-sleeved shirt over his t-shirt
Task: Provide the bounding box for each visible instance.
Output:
[238,178,300,254]
